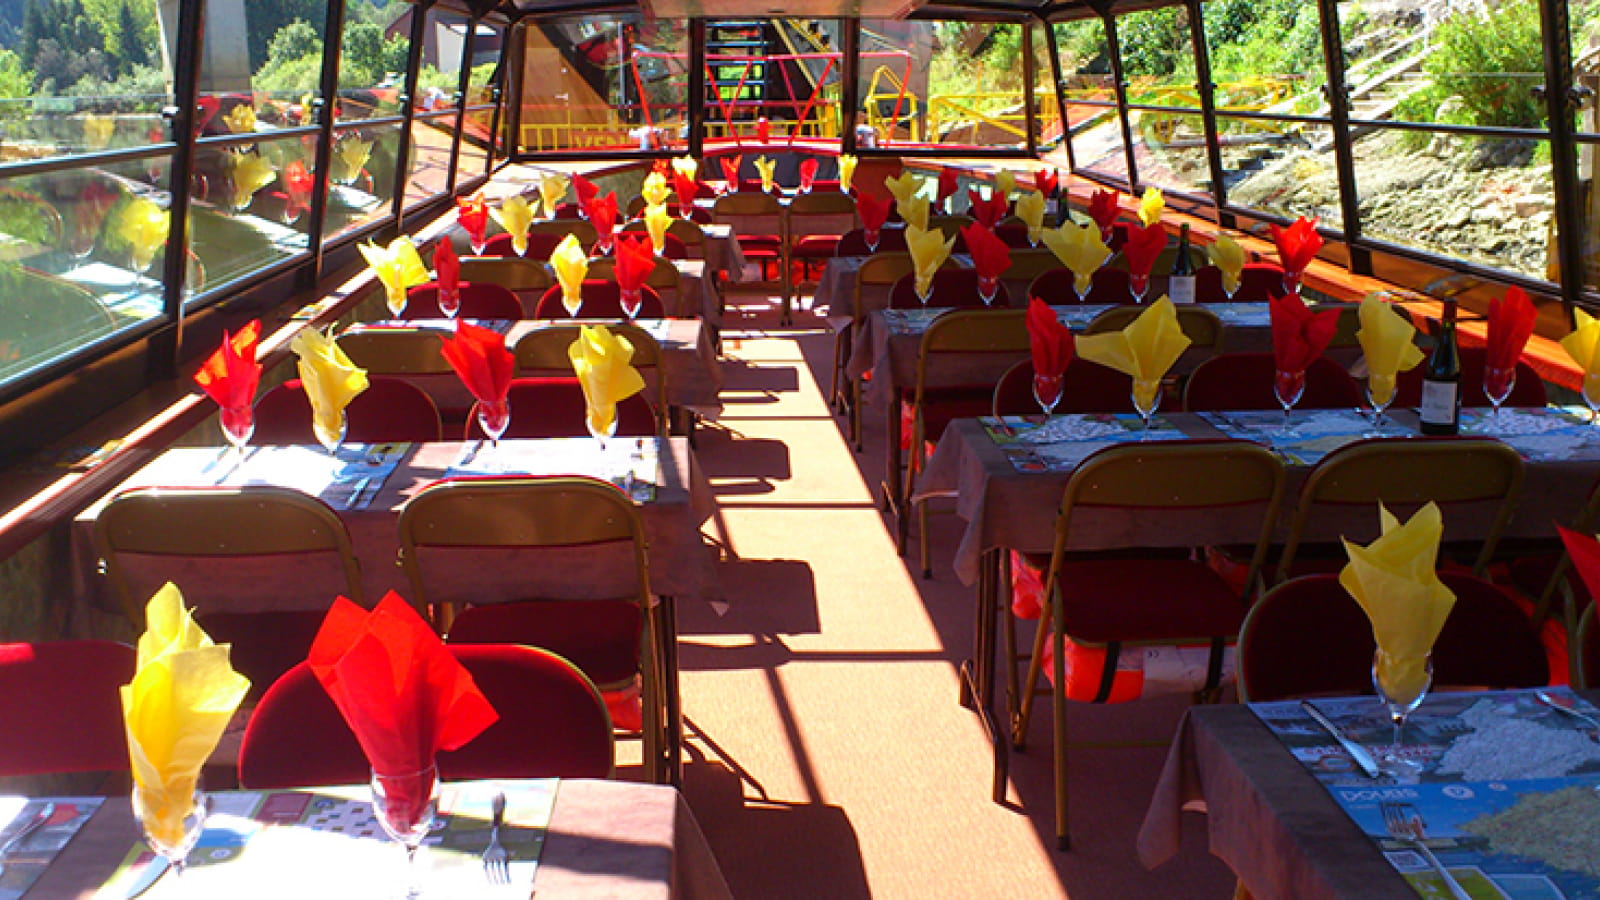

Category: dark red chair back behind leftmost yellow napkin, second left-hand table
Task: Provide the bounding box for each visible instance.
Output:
[251,375,443,444]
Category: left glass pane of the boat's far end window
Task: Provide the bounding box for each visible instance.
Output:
[518,16,688,152]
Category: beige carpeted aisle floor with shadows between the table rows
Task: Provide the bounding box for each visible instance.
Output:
[662,295,1234,900]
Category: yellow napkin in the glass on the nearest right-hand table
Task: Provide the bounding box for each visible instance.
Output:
[1339,503,1456,703]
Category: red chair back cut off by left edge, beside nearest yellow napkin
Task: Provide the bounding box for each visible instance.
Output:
[0,641,134,777]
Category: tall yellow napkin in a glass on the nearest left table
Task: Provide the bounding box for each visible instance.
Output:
[122,583,250,847]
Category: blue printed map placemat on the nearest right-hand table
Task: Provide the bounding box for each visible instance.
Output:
[1250,689,1600,900]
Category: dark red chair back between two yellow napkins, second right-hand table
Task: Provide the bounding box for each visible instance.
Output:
[1184,352,1362,413]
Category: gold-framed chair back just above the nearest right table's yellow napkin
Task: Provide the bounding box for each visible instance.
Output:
[1278,437,1523,581]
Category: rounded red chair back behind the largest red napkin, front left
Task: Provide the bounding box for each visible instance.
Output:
[238,644,616,790]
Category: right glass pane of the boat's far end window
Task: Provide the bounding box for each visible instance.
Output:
[856,19,1027,149]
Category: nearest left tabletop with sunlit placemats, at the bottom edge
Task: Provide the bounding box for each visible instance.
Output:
[0,778,731,900]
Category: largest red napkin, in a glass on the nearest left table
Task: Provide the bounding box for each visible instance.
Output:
[306,591,499,810]
